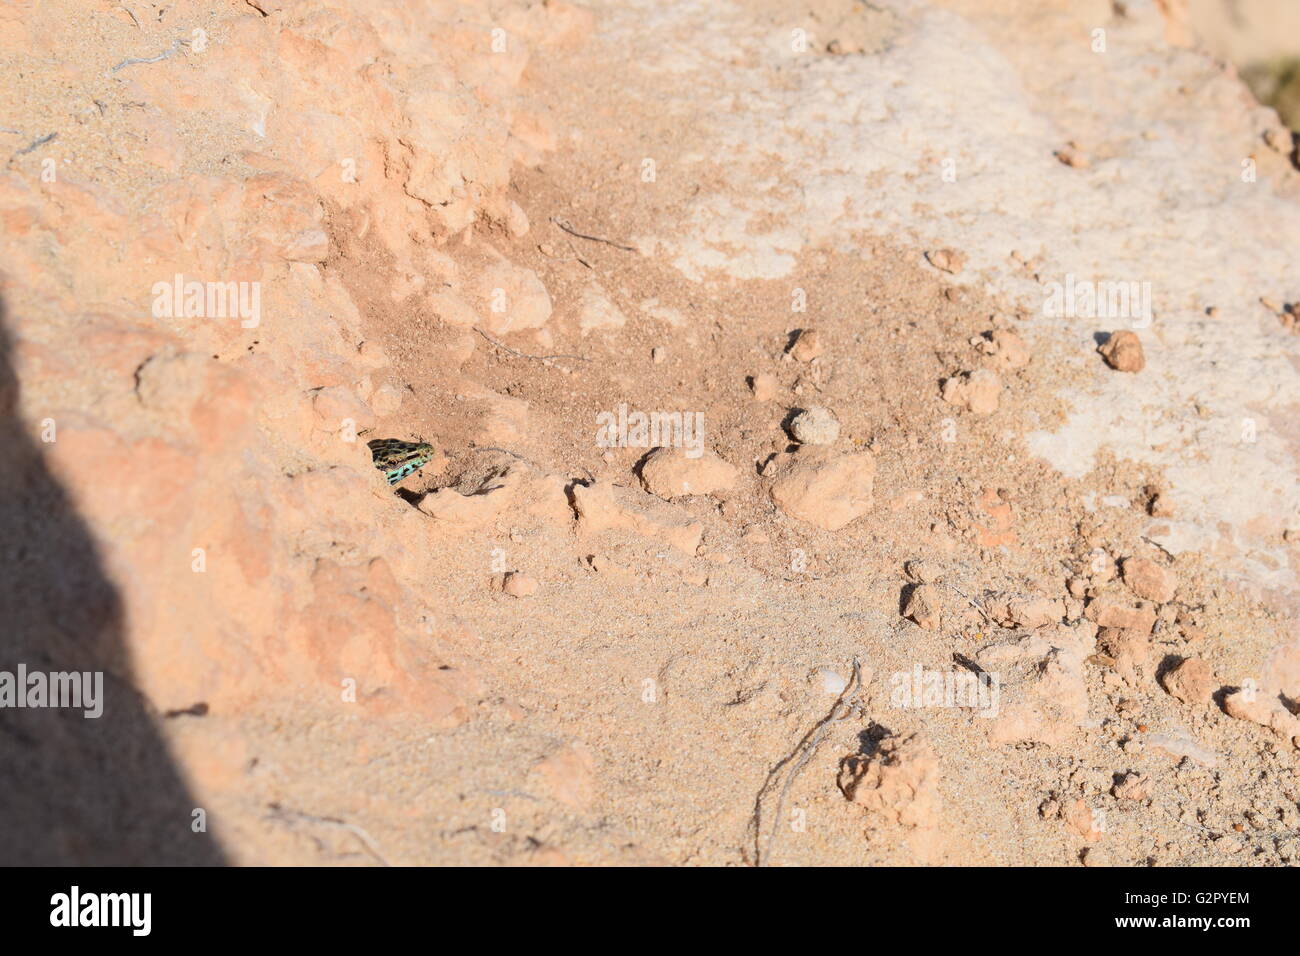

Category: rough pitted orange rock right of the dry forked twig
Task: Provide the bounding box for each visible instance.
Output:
[836,734,940,827]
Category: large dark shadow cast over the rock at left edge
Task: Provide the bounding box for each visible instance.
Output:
[0,303,225,866]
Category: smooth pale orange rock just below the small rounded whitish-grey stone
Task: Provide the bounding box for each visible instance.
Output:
[764,446,876,531]
